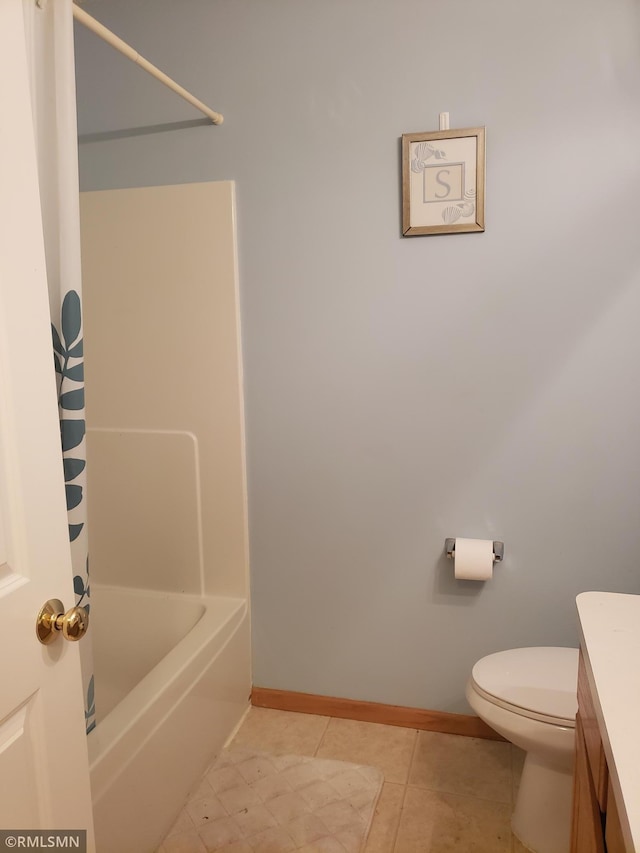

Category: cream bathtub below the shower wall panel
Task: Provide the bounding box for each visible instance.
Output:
[87,583,251,853]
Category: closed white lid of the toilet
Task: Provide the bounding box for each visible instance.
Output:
[472,646,578,725]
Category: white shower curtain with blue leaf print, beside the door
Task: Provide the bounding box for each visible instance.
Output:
[23,0,95,733]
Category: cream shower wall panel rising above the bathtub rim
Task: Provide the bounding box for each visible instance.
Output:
[81,181,248,596]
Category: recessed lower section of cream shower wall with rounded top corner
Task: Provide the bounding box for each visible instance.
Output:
[87,429,203,594]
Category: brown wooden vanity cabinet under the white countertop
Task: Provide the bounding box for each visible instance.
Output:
[571,651,626,853]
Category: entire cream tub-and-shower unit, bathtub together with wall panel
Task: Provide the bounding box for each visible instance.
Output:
[81,182,251,853]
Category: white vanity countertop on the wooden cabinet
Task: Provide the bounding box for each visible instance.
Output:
[576,592,640,853]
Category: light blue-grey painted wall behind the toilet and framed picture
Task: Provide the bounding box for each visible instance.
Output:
[77,0,640,712]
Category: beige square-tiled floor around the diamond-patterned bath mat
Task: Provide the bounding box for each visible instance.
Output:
[158,708,526,853]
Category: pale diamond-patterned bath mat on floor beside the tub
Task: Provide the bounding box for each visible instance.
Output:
[161,748,383,853]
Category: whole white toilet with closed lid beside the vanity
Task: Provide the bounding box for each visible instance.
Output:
[466,646,578,853]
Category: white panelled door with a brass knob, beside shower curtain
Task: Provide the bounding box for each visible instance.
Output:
[0,0,95,851]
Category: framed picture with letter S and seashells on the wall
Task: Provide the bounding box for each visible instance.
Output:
[402,127,485,237]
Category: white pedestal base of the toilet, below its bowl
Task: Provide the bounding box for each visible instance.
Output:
[511,752,573,853]
